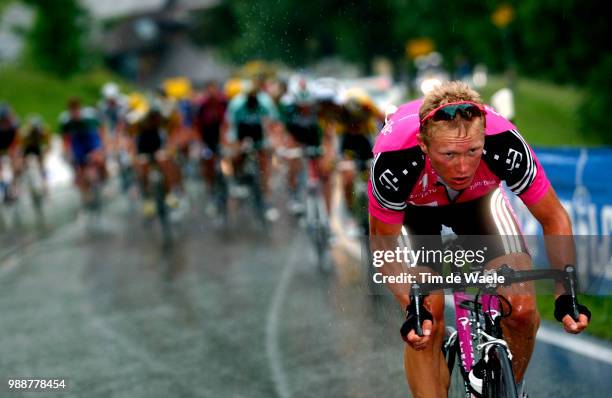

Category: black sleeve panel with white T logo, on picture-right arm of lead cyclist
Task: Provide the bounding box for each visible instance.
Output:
[482,130,538,195]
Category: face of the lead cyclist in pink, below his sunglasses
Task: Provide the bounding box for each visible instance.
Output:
[419,120,484,190]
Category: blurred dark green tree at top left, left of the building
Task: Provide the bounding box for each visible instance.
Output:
[26,0,90,77]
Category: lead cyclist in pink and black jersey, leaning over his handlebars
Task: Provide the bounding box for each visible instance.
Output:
[369,82,591,397]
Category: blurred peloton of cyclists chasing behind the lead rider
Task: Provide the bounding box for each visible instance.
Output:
[0,75,384,232]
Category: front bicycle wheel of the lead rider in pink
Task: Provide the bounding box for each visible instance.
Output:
[483,345,518,398]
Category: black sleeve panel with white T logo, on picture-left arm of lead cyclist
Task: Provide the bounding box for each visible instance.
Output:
[370,147,425,211]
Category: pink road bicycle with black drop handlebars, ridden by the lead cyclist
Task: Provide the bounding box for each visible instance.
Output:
[401,265,579,398]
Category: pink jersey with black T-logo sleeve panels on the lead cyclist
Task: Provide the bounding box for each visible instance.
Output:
[368,100,550,224]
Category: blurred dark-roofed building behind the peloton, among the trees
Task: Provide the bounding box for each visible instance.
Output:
[97,0,231,86]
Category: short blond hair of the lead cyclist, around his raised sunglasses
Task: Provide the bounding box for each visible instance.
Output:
[419,81,484,143]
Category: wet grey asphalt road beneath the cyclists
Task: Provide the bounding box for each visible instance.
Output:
[0,184,612,398]
